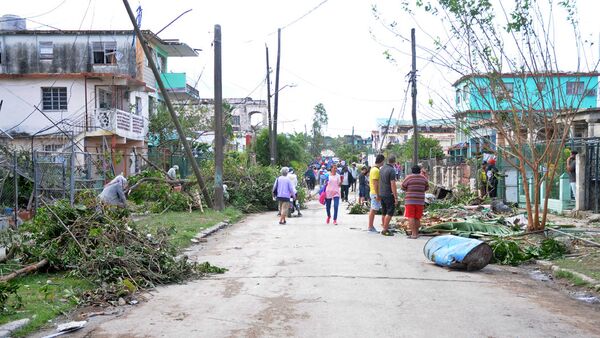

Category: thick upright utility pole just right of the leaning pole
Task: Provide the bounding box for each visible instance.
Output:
[214,25,225,211]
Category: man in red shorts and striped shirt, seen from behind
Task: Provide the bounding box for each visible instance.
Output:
[401,165,429,238]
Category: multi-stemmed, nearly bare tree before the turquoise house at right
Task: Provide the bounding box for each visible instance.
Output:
[373,0,598,231]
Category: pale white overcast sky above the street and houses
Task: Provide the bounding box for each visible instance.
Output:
[0,0,600,137]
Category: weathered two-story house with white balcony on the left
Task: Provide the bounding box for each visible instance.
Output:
[0,21,197,175]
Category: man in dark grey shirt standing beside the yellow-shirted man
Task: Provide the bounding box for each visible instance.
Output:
[379,155,398,236]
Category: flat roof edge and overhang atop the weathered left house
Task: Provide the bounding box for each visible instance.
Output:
[0,29,198,56]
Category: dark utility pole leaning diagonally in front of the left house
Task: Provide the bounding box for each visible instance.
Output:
[123,0,212,208]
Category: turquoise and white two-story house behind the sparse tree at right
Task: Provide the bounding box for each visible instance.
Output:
[450,73,599,161]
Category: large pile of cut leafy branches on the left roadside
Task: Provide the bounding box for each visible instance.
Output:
[12,201,213,302]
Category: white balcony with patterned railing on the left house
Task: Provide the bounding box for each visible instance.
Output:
[92,108,146,141]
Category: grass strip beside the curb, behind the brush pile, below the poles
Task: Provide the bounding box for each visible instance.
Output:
[136,207,242,248]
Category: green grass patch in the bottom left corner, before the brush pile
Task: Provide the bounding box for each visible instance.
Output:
[0,273,93,337]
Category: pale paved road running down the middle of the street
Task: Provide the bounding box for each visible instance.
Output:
[69,202,600,337]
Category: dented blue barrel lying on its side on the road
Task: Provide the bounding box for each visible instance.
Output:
[423,235,493,271]
